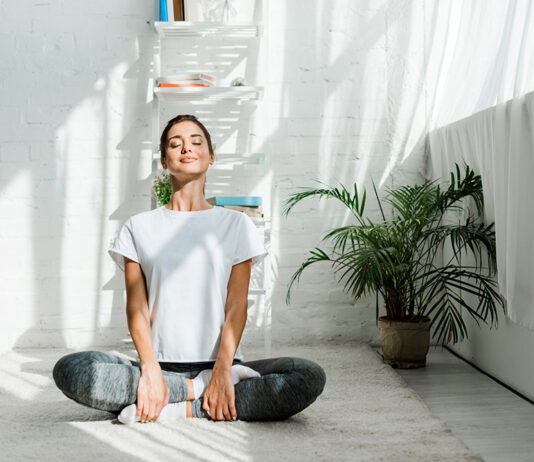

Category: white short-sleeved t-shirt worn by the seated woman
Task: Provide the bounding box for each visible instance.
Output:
[108,206,268,362]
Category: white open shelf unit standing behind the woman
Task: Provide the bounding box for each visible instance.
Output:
[153,21,271,357]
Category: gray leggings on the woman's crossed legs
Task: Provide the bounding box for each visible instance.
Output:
[53,351,326,421]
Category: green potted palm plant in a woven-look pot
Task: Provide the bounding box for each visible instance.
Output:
[284,164,504,368]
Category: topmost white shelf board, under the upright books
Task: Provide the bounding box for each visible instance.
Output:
[154,21,262,39]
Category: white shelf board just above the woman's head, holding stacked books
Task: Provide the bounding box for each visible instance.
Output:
[154,86,263,101]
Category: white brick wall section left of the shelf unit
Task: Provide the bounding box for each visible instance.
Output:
[0,0,154,349]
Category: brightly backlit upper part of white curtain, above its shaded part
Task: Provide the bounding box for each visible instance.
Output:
[423,0,534,131]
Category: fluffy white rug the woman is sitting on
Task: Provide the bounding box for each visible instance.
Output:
[0,343,482,462]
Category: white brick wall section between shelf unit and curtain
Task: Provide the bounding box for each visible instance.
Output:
[268,1,432,343]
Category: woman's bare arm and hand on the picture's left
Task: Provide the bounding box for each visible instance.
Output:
[124,257,170,421]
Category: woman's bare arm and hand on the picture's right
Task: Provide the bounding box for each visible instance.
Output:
[202,259,252,420]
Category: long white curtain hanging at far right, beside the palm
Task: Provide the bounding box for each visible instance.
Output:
[424,0,534,329]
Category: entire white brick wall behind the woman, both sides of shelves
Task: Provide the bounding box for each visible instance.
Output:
[0,0,425,350]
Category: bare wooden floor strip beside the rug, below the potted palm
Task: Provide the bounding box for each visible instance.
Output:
[375,347,534,462]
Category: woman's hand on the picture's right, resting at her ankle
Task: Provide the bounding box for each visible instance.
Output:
[202,366,237,420]
